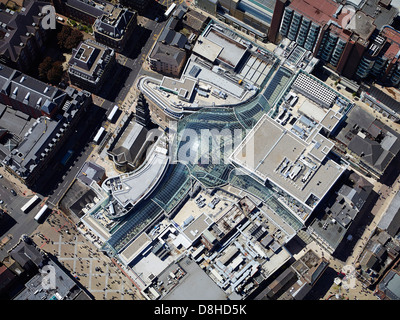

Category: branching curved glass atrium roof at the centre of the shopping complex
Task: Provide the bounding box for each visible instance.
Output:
[103,67,302,253]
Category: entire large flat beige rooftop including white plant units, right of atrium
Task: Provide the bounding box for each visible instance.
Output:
[231,115,345,216]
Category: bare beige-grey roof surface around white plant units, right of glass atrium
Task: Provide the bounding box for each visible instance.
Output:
[232,115,344,211]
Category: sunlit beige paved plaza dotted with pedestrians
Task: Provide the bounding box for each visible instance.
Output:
[32,211,143,300]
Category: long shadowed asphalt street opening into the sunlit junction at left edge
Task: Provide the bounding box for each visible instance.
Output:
[0,6,178,260]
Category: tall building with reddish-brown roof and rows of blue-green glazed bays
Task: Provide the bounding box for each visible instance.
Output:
[280,0,376,78]
